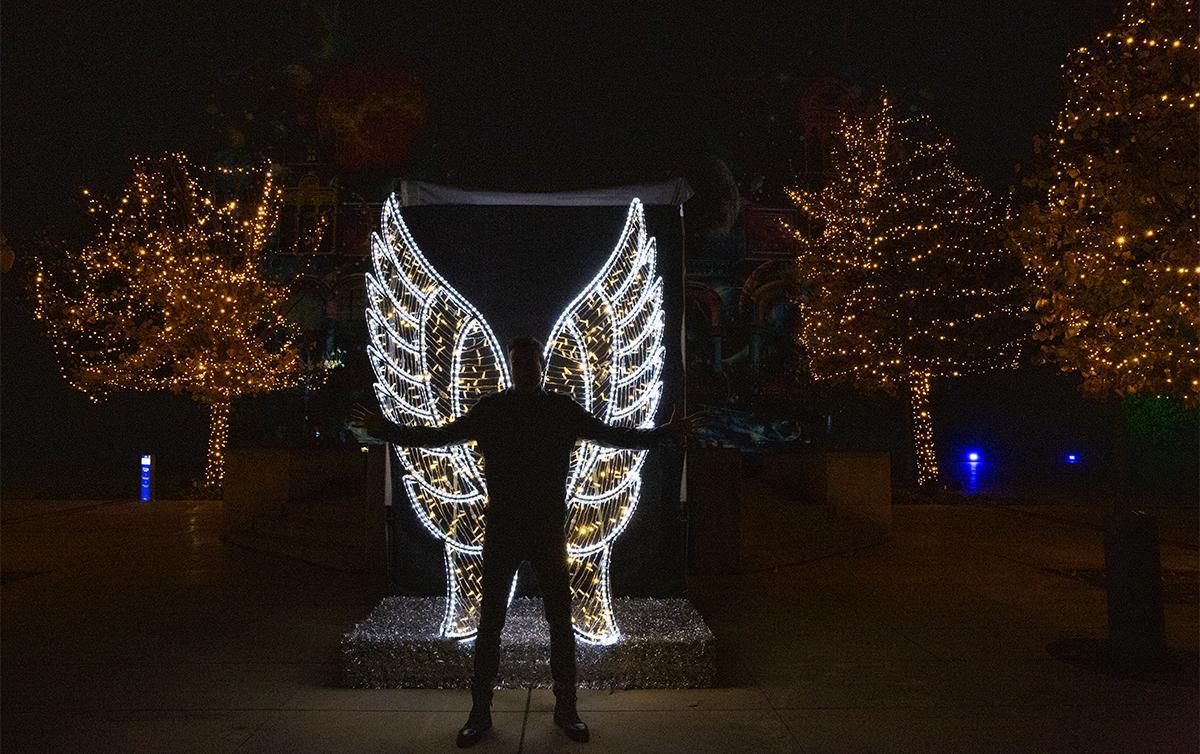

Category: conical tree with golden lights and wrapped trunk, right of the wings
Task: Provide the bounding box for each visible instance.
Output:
[790,97,1022,486]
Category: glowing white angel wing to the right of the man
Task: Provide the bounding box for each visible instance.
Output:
[545,199,666,641]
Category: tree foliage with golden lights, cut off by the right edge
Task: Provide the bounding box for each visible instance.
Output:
[1013,0,1200,405]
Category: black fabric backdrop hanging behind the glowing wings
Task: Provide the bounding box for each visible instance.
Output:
[381,185,685,597]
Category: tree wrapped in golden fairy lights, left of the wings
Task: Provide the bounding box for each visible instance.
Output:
[34,154,324,490]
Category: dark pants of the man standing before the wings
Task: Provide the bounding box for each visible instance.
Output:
[470,521,575,704]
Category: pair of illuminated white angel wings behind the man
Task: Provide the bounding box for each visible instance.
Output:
[367,197,666,644]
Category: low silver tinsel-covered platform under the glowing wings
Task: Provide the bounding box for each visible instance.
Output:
[342,597,713,688]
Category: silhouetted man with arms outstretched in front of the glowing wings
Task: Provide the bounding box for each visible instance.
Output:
[352,337,696,747]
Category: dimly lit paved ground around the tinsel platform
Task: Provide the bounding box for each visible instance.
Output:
[0,502,1200,753]
